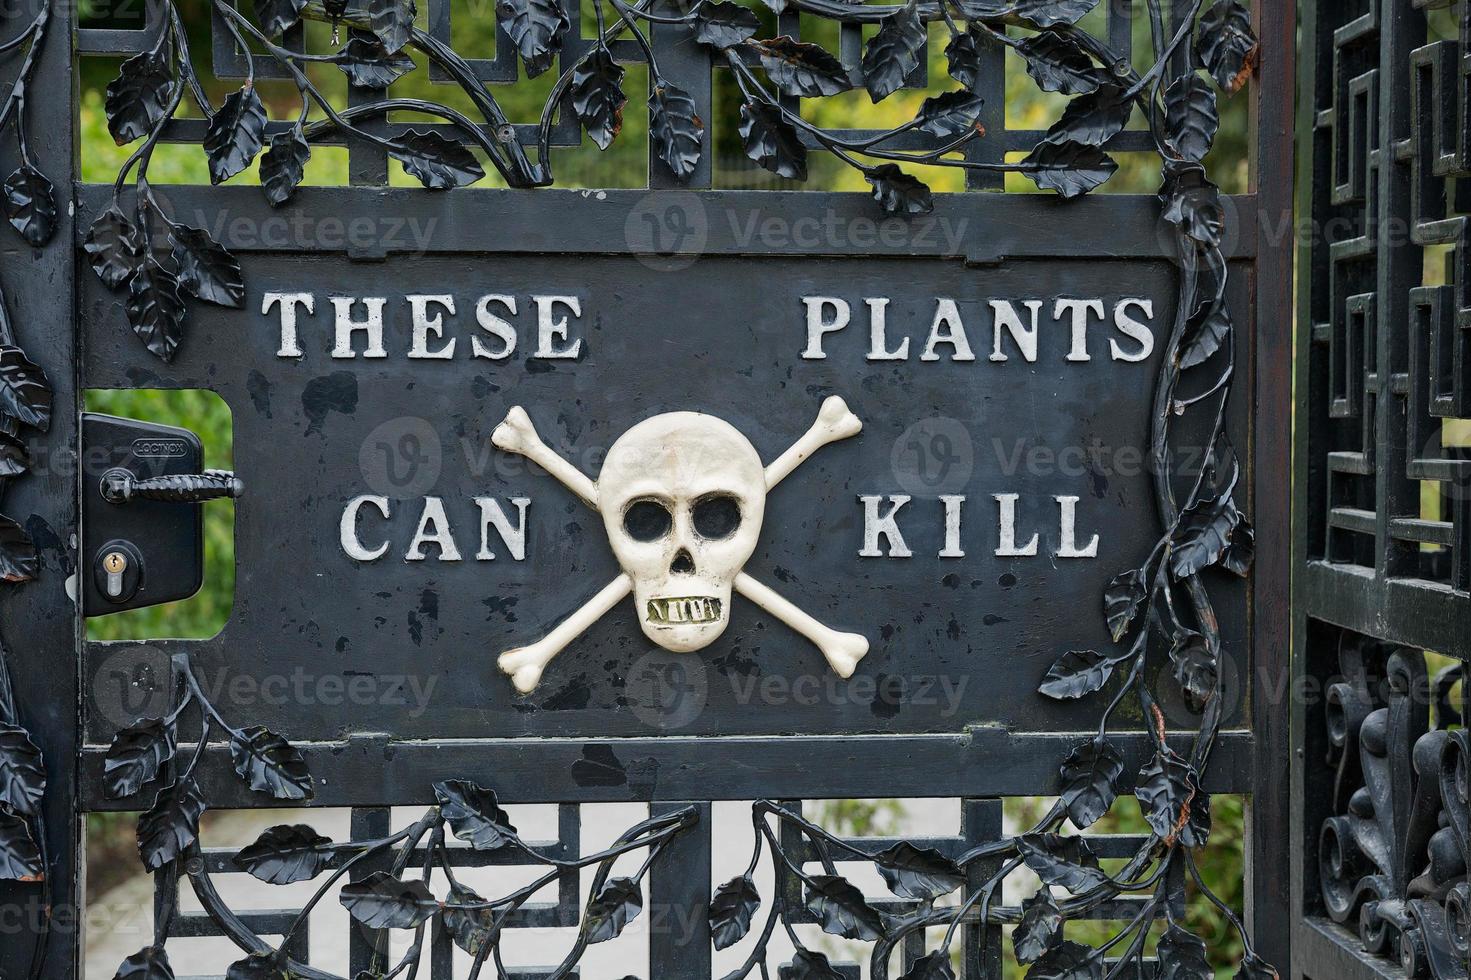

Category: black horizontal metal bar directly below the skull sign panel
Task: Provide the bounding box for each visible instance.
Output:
[81,728,1252,811]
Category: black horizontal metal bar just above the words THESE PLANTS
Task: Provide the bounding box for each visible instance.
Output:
[76,184,1256,263]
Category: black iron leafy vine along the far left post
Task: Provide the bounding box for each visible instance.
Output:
[0,3,57,974]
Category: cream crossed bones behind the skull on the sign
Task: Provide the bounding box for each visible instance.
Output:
[490,396,868,695]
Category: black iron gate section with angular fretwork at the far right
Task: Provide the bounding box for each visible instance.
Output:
[1293,0,1471,980]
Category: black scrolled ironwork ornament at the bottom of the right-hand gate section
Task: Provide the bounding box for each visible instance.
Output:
[1318,633,1471,980]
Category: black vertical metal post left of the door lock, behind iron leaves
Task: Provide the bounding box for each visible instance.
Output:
[0,0,82,980]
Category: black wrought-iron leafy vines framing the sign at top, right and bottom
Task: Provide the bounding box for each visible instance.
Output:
[85,0,1277,980]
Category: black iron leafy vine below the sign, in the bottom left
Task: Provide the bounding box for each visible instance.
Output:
[104,655,697,980]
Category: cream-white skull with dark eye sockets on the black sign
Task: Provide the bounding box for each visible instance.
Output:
[597,412,766,653]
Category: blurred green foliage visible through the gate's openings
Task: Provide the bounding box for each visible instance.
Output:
[79,0,1250,977]
